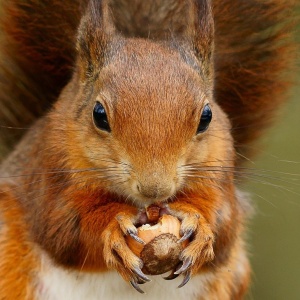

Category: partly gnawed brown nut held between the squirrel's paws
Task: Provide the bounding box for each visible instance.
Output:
[126,215,188,275]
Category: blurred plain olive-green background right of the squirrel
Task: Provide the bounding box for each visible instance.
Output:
[243,83,300,300]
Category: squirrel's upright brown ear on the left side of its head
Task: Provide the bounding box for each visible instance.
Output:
[77,0,116,75]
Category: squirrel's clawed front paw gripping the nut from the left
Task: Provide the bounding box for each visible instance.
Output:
[102,213,150,293]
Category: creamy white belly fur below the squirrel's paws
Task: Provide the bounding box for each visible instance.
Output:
[37,253,209,300]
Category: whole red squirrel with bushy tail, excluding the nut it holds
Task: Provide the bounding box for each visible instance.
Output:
[0,0,293,300]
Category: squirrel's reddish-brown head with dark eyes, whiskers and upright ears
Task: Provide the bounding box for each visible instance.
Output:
[48,1,233,206]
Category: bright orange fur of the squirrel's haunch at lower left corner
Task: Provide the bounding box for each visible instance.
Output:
[0,190,39,300]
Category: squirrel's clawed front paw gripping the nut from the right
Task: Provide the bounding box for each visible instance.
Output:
[165,203,214,287]
